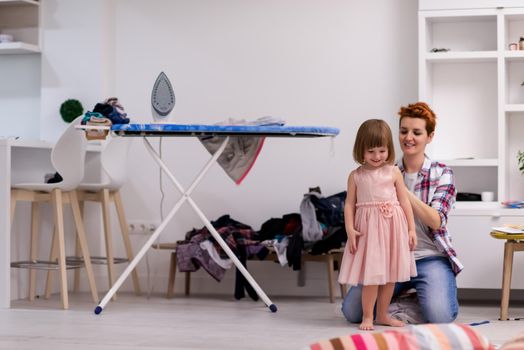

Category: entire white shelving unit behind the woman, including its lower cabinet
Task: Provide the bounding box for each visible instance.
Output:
[419,0,524,289]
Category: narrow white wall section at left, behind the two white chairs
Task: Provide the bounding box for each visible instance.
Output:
[40,0,114,141]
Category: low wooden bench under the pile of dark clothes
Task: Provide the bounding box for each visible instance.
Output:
[160,243,347,303]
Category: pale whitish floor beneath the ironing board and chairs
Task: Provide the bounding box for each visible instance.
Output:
[0,294,524,350]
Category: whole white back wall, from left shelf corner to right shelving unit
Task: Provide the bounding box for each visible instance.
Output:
[9,0,417,295]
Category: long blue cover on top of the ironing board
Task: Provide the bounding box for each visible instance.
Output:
[111,124,340,137]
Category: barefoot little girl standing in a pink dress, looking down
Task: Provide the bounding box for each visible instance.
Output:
[338,119,417,330]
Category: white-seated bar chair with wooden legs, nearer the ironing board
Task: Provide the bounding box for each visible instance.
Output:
[75,136,141,295]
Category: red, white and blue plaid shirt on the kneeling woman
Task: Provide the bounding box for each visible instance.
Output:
[397,156,464,274]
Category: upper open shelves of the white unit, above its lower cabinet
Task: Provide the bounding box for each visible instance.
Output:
[419,0,524,207]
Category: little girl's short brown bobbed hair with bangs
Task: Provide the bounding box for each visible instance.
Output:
[353,119,395,164]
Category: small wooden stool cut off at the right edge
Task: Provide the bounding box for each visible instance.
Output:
[490,231,524,321]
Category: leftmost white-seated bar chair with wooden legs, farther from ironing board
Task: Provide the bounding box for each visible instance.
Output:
[11,117,98,309]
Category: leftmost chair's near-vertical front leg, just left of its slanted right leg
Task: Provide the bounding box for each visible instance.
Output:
[51,189,69,309]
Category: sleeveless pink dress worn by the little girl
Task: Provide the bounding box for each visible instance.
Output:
[338,165,417,285]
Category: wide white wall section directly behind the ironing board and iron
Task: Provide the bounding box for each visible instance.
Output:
[115,0,416,238]
